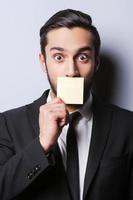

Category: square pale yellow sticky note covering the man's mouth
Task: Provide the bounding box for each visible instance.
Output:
[57,77,84,104]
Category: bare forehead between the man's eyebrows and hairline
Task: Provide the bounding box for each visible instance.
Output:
[46,27,94,50]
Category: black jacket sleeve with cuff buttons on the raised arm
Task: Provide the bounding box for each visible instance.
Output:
[0,114,54,200]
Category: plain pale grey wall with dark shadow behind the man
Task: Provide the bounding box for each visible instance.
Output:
[0,0,133,111]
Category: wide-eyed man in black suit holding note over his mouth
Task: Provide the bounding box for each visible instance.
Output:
[0,9,133,200]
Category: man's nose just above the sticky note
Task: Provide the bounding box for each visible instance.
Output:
[65,60,79,77]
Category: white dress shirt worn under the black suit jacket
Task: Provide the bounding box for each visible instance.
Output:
[47,92,93,200]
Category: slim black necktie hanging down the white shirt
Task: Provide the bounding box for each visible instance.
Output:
[67,112,80,200]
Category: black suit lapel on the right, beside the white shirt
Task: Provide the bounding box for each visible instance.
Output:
[83,100,112,199]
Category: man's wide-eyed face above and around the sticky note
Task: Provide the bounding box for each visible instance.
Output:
[40,27,98,100]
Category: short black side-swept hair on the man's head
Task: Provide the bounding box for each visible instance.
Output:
[40,9,101,56]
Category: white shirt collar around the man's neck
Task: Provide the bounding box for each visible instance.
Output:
[47,90,93,121]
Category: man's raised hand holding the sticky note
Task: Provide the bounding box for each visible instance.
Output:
[39,97,68,153]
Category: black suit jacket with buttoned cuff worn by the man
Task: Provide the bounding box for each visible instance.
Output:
[0,91,133,200]
